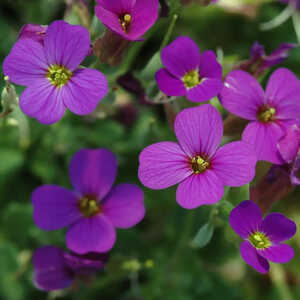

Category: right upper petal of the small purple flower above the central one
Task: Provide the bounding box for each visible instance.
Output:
[199,50,222,81]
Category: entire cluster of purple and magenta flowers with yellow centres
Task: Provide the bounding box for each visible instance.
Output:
[3,0,300,290]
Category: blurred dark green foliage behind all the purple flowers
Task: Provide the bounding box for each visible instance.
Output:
[0,0,300,300]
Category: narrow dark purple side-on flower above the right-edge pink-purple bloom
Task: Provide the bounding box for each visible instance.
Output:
[238,42,298,77]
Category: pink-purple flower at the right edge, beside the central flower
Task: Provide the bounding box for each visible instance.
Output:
[220,68,300,164]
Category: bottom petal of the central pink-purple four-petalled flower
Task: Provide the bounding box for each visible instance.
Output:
[176,170,224,209]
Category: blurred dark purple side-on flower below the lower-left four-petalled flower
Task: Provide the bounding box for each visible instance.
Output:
[32,246,108,291]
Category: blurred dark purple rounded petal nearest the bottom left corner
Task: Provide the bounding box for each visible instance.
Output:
[32,246,74,291]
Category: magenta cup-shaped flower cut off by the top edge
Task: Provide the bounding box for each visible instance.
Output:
[95,0,159,41]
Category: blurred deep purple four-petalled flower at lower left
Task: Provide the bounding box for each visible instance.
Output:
[32,149,145,254]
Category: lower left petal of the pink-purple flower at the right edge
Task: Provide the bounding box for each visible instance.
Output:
[242,122,284,164]
